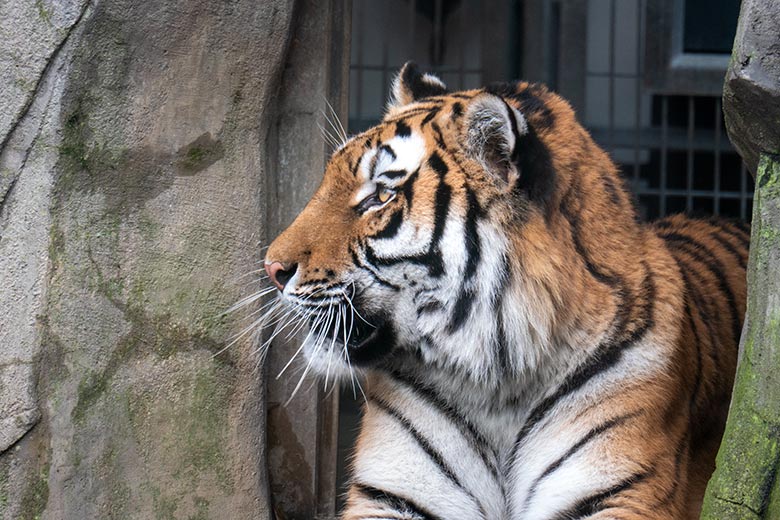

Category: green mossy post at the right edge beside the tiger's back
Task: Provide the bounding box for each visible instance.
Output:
[701,155,780,520]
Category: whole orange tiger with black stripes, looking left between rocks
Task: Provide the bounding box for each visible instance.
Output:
[264,62,750,520]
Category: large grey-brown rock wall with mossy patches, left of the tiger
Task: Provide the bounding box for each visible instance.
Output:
[0,0,300,520]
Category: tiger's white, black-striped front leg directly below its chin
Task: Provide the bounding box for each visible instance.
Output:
[342,376,505,520]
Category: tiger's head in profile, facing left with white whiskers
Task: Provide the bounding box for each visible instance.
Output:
[265,63,632,386]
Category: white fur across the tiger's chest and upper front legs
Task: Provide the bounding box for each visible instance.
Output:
[355,328,665,520]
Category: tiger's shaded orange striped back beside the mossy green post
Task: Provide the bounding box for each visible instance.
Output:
[652,215,750,518]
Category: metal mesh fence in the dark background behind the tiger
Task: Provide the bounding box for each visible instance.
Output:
[349,0,753,219]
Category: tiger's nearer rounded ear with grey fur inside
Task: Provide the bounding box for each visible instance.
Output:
[464,94,528,186]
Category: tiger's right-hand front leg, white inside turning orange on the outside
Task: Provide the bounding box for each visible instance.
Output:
[508,374,704,520]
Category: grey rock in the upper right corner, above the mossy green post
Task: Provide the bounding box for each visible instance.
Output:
[723,0,780,174]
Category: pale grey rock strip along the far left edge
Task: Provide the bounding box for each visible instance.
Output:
[0,1,86,458]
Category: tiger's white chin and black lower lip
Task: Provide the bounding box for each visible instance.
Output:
[303,316,397,378]
